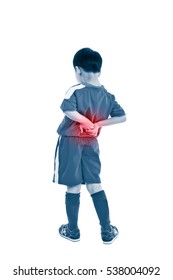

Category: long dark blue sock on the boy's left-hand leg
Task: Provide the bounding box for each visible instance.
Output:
[65,192,80,230]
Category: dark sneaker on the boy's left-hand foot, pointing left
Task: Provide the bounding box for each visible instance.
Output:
[59,224,80,242]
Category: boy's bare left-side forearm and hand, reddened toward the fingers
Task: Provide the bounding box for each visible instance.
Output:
[64,111,94,133]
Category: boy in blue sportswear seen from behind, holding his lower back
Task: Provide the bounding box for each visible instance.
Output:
[53,48,126,244]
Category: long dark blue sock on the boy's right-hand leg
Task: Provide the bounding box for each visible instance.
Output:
[91,191,111,230]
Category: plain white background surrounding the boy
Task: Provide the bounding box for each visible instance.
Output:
[0,0,173,280]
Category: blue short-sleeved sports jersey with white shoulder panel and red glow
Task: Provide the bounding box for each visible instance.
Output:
[57,84,125,137]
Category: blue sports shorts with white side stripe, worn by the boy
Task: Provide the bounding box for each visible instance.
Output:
[53,136,101,187]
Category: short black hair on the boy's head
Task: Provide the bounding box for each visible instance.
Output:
[73,48,102,73]
